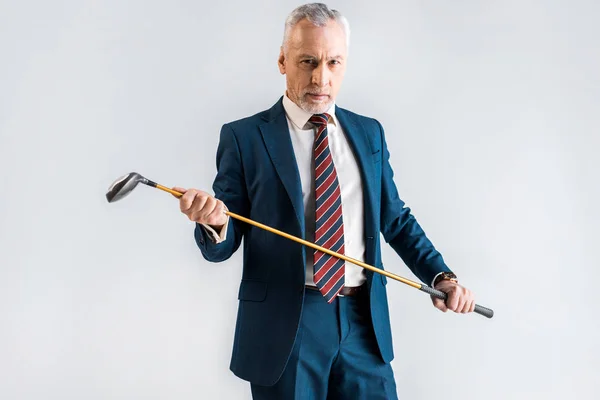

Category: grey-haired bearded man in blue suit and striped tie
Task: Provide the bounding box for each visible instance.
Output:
[175,4,475,400]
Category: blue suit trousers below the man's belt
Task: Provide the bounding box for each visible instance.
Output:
[251,289,398,400]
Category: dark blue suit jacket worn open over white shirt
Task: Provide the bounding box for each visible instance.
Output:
[194,97,449,386]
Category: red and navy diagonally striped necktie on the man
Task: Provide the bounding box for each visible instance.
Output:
[309,114,345,303]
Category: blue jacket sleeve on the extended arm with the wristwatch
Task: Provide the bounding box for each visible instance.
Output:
[376,121,450,285]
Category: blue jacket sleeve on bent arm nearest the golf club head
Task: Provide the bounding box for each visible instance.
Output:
[194,124,250,262]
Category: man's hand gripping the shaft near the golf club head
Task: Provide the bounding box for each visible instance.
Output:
[173,187,228,232]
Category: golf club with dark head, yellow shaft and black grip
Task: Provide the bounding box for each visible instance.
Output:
[106,172,494,318]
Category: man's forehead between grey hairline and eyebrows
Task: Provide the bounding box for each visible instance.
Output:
[288,19,347,55]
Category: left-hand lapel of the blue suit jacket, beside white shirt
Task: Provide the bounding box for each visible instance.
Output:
[259,96,305,237]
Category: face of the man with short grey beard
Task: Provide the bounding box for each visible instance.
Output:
[278,19,348,114]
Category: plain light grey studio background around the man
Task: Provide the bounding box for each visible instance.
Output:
[0,0,600,400]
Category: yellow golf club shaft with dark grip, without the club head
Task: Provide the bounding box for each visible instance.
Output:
[161,184,494,318]
